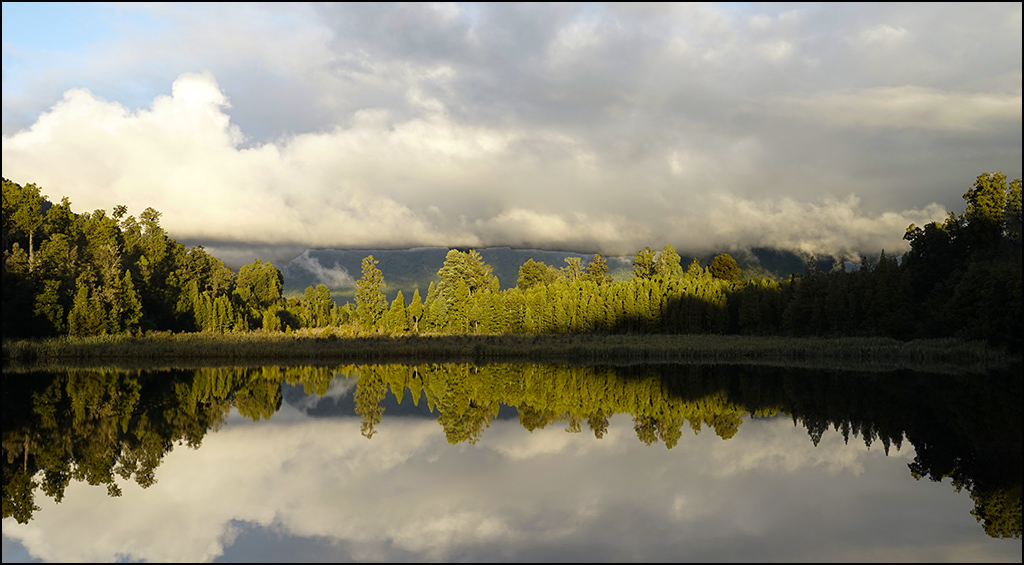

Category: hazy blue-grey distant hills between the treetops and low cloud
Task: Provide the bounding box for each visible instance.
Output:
[281,247,833,304]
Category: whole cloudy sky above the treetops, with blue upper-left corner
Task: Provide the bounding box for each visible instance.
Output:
[2,2,1022,263]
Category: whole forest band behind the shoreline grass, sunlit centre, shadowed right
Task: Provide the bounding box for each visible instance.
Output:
[2,173,1022,352]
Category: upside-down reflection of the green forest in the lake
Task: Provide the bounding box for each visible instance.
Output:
[3,363,1021,538]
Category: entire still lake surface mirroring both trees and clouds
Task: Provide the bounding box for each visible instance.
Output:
[3,365,1021,561]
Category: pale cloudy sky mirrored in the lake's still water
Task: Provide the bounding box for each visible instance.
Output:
[3,381,1021,562]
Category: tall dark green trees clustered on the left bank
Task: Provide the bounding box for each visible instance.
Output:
[3,180,243,337]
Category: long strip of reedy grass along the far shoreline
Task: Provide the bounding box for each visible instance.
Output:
[3,332,1021,373]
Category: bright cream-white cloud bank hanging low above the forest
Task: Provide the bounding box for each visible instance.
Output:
[3,73,954,264]
